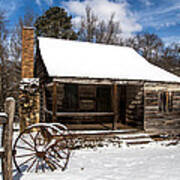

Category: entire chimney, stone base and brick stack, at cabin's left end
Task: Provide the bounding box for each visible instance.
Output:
[18,27,40,132]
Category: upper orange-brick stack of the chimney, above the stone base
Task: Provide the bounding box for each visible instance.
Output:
[21,27,34,78]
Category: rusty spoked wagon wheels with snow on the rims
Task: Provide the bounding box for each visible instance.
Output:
[13,123,70,173]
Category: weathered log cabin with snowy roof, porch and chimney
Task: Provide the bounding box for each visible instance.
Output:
[19,27,180,133]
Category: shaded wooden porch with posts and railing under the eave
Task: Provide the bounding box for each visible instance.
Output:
[42,78,144,130]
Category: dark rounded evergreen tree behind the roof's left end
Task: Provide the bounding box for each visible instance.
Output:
[34,7,77,40]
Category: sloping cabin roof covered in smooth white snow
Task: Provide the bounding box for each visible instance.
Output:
[38,37,180,82]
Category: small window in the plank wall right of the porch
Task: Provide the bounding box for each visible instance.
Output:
[159,91,173,112]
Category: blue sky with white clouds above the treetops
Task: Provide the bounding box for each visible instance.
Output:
[0,0,180,44]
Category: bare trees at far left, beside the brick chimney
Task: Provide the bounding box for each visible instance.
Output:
[0,11,35,111]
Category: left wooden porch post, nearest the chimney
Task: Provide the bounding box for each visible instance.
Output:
[52,82,57,122]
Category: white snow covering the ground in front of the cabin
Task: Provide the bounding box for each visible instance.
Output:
[0,128,180,180]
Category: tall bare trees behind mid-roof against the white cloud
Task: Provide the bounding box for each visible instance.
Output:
[78,7,121,44]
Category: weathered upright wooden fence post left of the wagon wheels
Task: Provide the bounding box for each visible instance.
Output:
[2,98,15,180]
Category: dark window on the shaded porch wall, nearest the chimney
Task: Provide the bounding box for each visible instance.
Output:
[63,84,78,112]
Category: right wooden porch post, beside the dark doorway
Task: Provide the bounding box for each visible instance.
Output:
[112,83,119,130]
